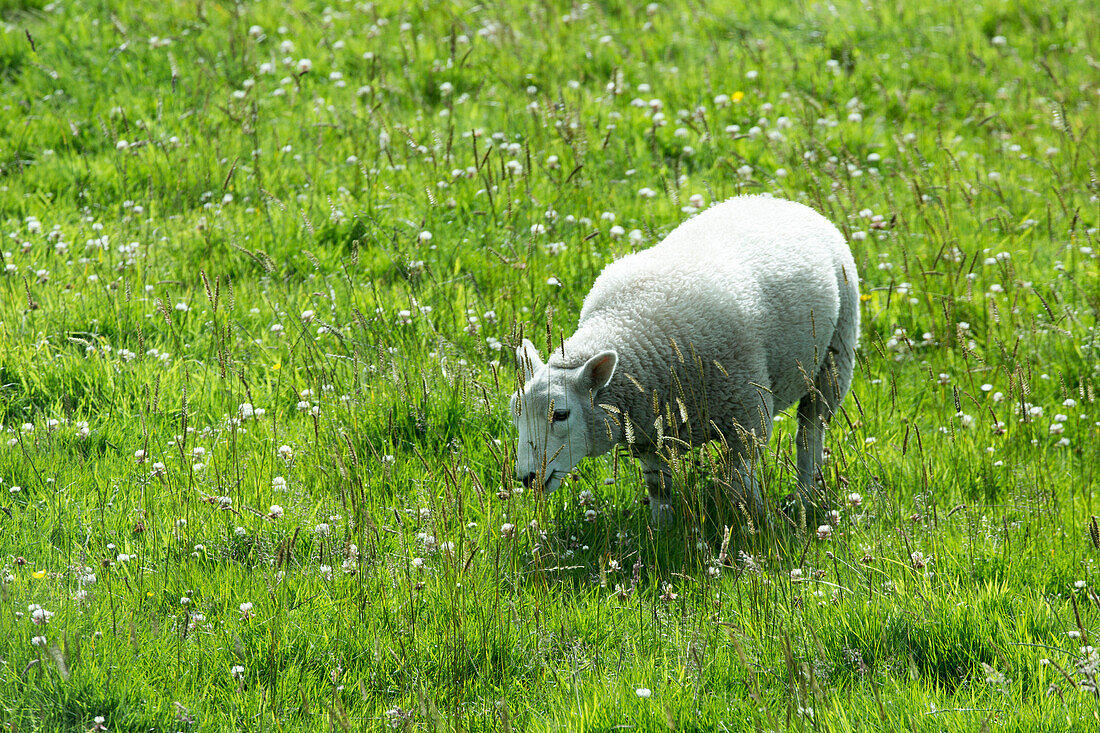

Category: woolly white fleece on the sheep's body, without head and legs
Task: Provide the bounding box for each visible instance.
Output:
[549,191,859,448]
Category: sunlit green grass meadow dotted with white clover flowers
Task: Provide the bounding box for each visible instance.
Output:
[0,0,1100,732]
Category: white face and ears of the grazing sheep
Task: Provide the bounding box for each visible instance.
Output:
[512,339,618,493]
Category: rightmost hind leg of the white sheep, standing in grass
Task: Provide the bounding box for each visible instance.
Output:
[795,336,855,506]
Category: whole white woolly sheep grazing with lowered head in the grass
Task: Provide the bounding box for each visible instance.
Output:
[512,196,859,524]
